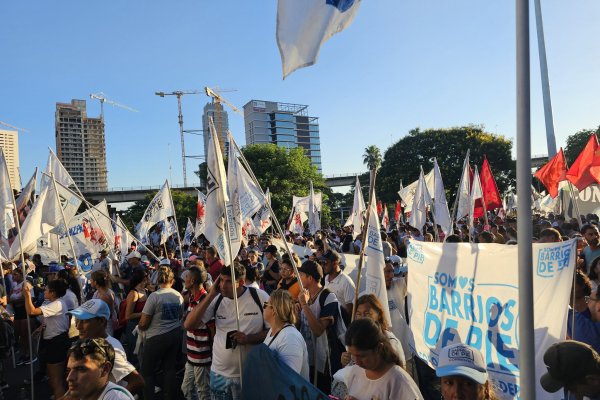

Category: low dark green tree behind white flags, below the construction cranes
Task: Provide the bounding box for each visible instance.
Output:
[121,190,198,234]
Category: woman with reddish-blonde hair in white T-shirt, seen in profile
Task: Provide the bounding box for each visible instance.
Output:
[264,289,309,380]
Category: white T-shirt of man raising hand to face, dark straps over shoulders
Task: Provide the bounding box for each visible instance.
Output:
[202,288,269,378]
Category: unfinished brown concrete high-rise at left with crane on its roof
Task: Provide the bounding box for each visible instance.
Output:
[55,100,108,192]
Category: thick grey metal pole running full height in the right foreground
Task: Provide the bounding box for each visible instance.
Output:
[515,0,536,399]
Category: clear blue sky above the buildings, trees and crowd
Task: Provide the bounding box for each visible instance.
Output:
[0,0,600,187]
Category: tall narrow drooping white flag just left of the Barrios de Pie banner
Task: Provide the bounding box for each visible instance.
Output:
[365,191,392,323]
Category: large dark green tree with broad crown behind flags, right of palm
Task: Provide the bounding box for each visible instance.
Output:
[377,125,515,203]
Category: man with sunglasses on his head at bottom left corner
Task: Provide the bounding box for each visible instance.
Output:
[66,338,134,400]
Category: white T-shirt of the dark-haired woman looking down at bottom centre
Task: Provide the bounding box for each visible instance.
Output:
[346,365,423,400]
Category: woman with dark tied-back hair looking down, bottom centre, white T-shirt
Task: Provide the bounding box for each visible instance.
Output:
[346,318,423,400]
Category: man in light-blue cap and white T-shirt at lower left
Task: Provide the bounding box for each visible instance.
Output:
[68,299,144,395]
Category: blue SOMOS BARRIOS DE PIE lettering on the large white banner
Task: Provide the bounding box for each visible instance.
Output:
[420,272,519,376]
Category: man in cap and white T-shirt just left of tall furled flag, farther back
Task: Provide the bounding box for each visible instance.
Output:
[317,250,356,315]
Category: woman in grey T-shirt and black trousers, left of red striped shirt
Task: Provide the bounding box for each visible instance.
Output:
[138,265,183,400]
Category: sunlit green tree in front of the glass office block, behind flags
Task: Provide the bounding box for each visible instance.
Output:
[242,144,331,225]
